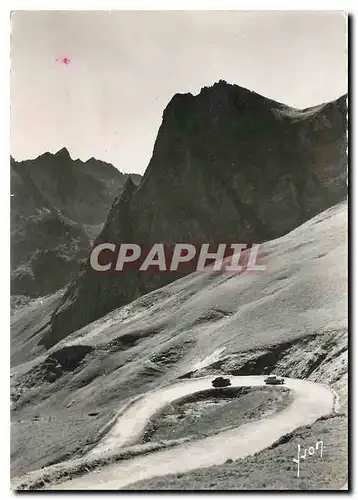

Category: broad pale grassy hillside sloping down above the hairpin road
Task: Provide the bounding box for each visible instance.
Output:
[12,203,347,474]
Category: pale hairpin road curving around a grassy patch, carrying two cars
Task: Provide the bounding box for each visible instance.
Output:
[50,375,334,490]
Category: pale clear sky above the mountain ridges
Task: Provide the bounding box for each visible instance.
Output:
[11,11,347,173]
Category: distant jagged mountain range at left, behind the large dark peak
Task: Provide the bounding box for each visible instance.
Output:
[11,149,141,297]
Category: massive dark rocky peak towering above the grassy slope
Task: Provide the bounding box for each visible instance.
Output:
[43,81,347,346]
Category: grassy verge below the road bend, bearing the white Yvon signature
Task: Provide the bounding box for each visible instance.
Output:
[128,415,348,490]
